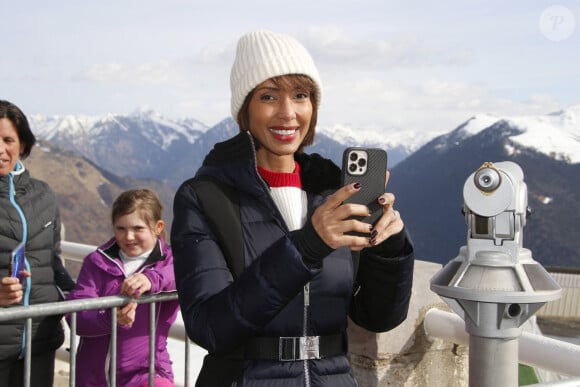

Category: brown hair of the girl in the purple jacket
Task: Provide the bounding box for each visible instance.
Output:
[111,188,166,240]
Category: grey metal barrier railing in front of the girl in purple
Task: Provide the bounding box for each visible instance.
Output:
[0,292,191,387]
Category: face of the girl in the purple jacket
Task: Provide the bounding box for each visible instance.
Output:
[113,212,164,257]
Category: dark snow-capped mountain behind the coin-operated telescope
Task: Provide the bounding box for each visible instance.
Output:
[389,106,580,267]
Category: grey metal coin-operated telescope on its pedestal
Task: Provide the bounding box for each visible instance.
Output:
[431,161,561,387]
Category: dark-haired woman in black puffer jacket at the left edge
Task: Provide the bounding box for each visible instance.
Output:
[0,100,74,387]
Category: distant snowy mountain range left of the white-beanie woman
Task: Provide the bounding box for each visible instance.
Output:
[30,109,208,188]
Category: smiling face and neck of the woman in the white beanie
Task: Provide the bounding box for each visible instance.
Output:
[248,80,313,172]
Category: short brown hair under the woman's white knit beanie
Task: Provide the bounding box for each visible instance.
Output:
[237,74,319,153]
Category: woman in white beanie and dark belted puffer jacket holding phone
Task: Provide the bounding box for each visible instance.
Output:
[171,31,414,387]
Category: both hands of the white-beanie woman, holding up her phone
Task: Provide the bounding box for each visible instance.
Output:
[312,172,404,251]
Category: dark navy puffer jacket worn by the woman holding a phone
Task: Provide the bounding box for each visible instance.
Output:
[171,132,414,387]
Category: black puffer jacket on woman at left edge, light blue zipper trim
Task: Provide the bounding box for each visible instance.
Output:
[0,163,74,361]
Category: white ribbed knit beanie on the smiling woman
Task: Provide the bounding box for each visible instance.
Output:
[230,30,322,121]
